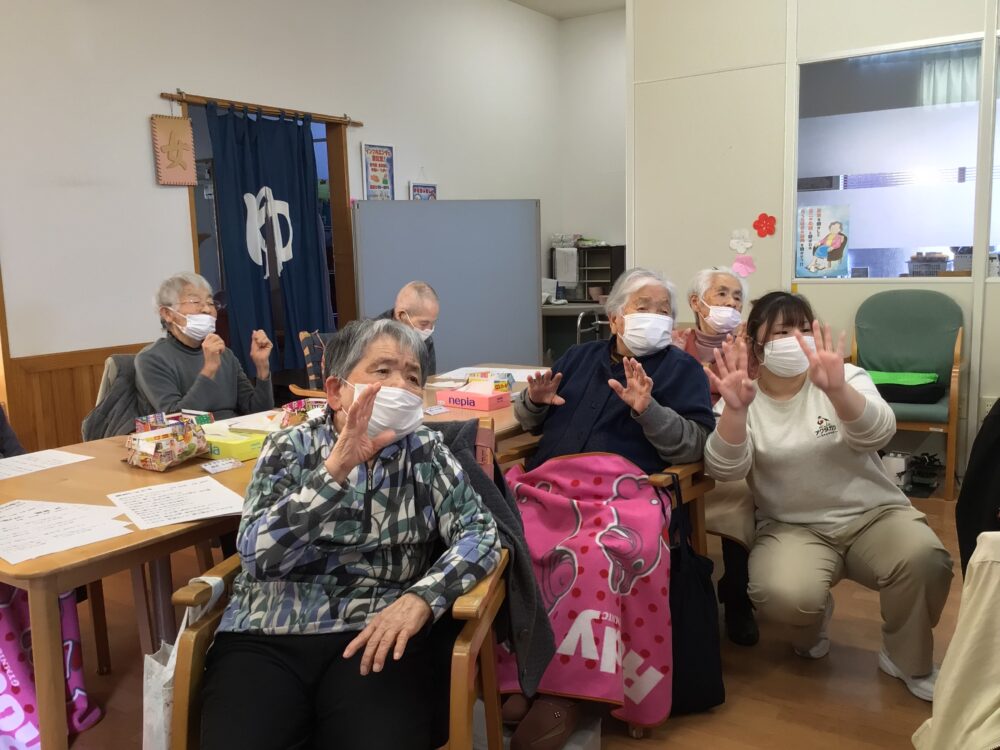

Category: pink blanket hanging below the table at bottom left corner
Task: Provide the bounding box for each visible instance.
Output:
[0,583,101,748]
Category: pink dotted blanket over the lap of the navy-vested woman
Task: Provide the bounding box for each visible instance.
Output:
[498,453,673,726]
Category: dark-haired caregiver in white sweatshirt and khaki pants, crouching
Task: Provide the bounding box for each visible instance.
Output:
[705,292,952,701]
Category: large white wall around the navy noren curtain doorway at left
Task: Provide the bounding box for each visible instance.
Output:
[0,0,563,357]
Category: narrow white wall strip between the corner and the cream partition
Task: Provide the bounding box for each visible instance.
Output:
[555,9,626,244]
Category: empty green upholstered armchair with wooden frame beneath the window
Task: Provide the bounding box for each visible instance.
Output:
[851,289,962,500]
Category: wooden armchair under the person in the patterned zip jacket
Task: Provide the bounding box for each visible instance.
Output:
[170,417,508,750]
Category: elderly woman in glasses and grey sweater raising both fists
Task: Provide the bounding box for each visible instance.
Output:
[135,273,274,419]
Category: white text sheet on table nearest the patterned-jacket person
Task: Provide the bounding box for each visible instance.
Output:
[108,477,243,529]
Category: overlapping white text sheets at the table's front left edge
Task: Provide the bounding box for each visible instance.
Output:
[0,500,131,565]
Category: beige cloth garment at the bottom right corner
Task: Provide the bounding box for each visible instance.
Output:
[913,532,1000,750]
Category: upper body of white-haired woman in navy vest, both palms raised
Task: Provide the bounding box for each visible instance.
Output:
[514,268,715,472]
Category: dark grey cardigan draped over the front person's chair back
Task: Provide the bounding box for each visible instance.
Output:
[431,419,556,697]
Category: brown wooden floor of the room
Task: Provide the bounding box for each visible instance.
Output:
[66,500,961,750]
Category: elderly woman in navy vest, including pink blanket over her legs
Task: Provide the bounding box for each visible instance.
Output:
[498,268,715,750]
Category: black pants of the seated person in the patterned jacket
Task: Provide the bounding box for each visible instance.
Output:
[201,618,457,750]
